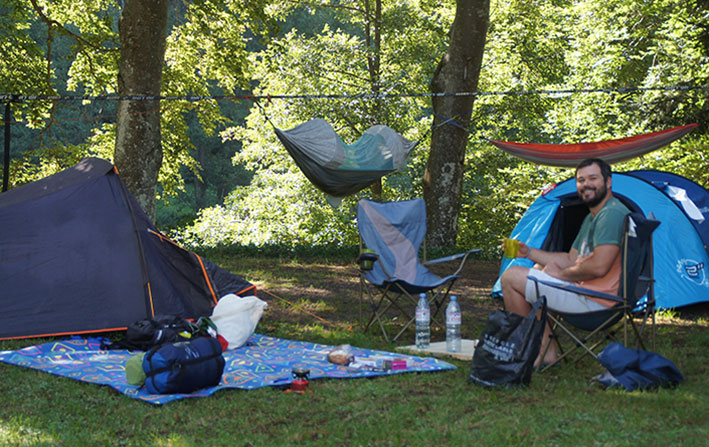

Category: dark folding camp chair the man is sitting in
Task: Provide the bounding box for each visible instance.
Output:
[529,212,660,372]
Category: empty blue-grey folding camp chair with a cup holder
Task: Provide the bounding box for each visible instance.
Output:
[357,199,480,342]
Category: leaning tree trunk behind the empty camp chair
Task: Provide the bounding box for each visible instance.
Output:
[423,0,490,247]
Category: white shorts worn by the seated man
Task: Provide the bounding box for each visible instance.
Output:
[524,269,608,314]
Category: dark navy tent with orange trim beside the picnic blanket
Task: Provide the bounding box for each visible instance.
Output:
[0,158,255,339]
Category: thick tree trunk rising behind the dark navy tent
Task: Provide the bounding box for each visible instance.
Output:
[114,0,169,220]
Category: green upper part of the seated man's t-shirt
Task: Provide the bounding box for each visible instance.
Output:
[572,197,630,258]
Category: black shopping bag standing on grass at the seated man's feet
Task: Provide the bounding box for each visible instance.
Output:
[468,297,547,387]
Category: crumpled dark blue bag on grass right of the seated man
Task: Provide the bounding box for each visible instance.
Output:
[595,342,684,391]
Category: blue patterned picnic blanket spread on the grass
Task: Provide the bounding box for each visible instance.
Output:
[0,334,455,405]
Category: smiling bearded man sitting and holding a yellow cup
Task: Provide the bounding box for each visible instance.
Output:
[501,158,630,368]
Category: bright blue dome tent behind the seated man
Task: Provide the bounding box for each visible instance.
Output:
[492,170,709,309]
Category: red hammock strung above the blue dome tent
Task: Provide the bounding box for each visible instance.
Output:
[489,124,697,167]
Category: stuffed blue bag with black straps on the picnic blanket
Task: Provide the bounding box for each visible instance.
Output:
[143,337,224,394]
